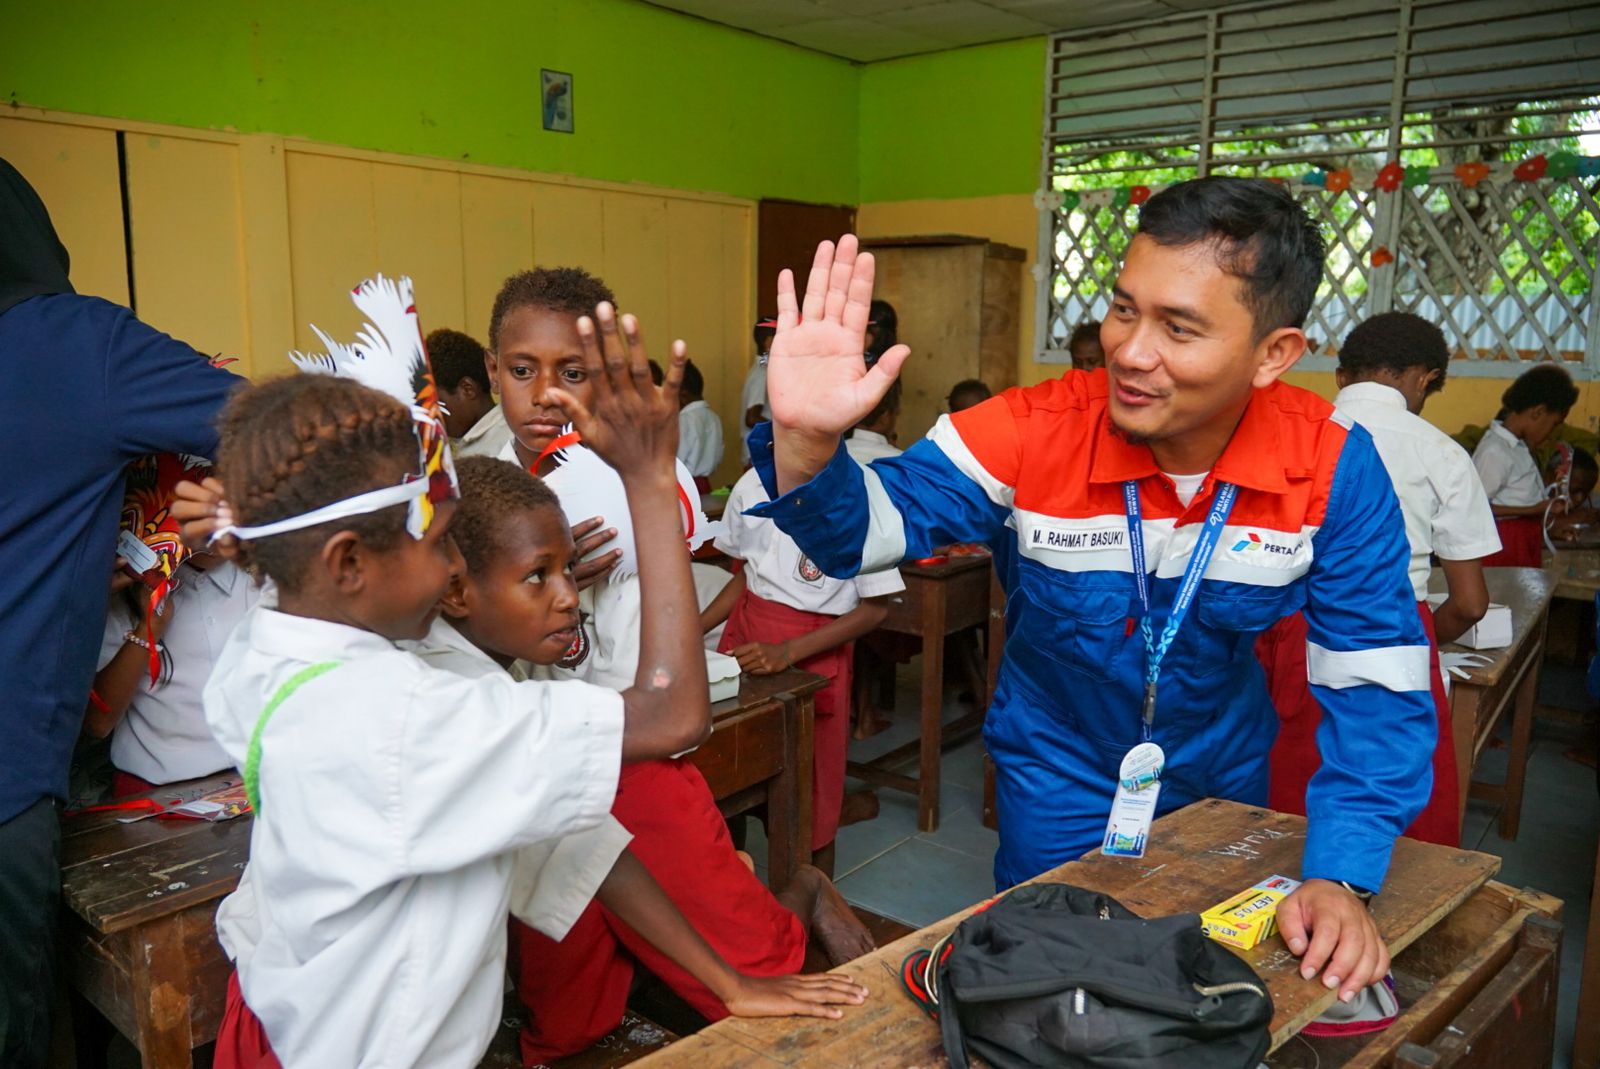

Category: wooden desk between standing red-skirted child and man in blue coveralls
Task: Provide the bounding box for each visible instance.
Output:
[846,554,1005,832]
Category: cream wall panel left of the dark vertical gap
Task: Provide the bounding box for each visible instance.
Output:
[0,118,128,307]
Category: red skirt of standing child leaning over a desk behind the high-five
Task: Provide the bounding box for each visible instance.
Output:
[717,591,856,850]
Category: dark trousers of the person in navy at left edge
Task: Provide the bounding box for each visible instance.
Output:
[0,799,61,1069]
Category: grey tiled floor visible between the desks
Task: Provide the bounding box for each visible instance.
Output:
[812,663,1600,1069]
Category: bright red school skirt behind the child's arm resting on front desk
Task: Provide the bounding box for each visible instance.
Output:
[510,759,806,1066]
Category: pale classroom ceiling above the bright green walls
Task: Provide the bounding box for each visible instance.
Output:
[651,0,1237,62]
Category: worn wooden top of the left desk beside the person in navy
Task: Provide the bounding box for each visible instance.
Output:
[61,773,253,935]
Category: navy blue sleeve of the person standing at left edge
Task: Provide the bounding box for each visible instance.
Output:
[94,301,245,459]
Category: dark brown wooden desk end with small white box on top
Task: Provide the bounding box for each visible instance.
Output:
[690,669,827,891]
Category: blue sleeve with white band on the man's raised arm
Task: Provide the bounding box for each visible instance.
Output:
[749,421,1010,579]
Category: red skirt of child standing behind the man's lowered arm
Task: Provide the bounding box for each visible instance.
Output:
[1256,602,1461,847]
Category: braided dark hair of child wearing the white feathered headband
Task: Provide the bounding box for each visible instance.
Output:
[216,374,418,591]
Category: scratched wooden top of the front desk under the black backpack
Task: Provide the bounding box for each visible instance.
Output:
[635,799,1499,1069]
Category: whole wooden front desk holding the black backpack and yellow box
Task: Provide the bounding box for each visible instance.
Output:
[635,800,1562,1069]
